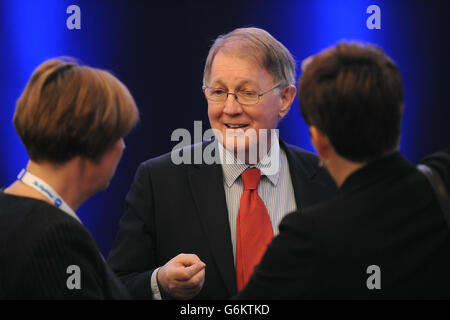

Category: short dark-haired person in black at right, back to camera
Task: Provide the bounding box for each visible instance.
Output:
[235,43,450,299]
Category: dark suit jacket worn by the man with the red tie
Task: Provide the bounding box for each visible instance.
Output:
[108,141,336,299]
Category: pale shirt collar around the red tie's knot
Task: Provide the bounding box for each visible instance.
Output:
[218,134,281,187]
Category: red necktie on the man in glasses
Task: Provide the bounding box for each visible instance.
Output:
[236,168,273,291]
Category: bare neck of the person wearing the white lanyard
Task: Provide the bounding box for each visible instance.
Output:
[5,159,88,211]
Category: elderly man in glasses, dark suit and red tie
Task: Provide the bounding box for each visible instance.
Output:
[109,28,336,299]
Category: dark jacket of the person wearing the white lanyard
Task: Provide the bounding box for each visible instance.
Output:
[0,191,130,299]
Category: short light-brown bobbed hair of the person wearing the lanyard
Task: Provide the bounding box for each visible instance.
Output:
[13,58,139,163]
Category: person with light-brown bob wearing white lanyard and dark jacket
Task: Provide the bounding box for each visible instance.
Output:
[0,59,139,299]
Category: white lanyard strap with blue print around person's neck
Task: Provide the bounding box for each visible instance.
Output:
[17,169,81,223]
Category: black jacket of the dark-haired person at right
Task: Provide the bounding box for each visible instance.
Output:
[236,152,450,299]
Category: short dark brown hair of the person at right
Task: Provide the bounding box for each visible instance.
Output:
[298,43,403,161]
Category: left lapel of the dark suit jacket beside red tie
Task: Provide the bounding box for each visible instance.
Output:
[189,152,236,295]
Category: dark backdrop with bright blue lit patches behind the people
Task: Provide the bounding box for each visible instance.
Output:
[0,0,450,255]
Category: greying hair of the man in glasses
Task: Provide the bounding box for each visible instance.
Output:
[203,28,296,86]
